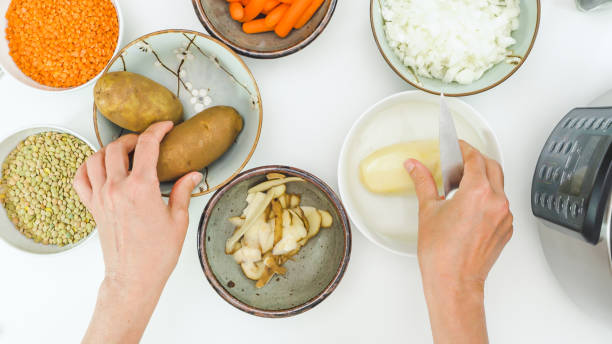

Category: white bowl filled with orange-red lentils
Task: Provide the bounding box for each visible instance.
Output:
[0,0,123,92]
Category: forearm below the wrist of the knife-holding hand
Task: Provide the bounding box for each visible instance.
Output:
[425,284,489,344]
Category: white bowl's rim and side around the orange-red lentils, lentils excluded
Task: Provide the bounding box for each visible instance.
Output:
[0,0,123,93]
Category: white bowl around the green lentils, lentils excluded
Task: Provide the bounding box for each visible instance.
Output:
[0,125,97,254]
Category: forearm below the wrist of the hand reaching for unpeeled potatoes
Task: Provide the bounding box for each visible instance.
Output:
[83,279,163,343]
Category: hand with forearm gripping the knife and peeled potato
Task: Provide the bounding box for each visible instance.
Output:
[405,142,513,343]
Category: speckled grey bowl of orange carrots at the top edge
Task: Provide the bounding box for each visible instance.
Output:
[192,0,337,59]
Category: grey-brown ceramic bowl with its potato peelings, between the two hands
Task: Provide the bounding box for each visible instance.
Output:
[198,166,351,318]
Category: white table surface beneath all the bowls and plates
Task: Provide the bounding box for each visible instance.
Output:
[0,0,612,344]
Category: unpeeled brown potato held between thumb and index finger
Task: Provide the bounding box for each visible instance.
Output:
[157,106,243,182]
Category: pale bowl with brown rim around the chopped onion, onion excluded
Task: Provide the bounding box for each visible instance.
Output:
[370,0,540,97]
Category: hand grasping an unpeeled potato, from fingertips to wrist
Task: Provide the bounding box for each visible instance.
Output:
[74,122,202,293]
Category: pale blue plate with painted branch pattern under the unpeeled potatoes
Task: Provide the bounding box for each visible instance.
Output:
[93,30,263,196]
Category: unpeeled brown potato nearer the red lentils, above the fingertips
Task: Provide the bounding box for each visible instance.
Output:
[94,72,183,133]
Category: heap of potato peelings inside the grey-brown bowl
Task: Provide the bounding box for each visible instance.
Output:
[225,177,333,288]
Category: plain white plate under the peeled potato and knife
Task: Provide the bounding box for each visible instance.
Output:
[338,91,502,256]
